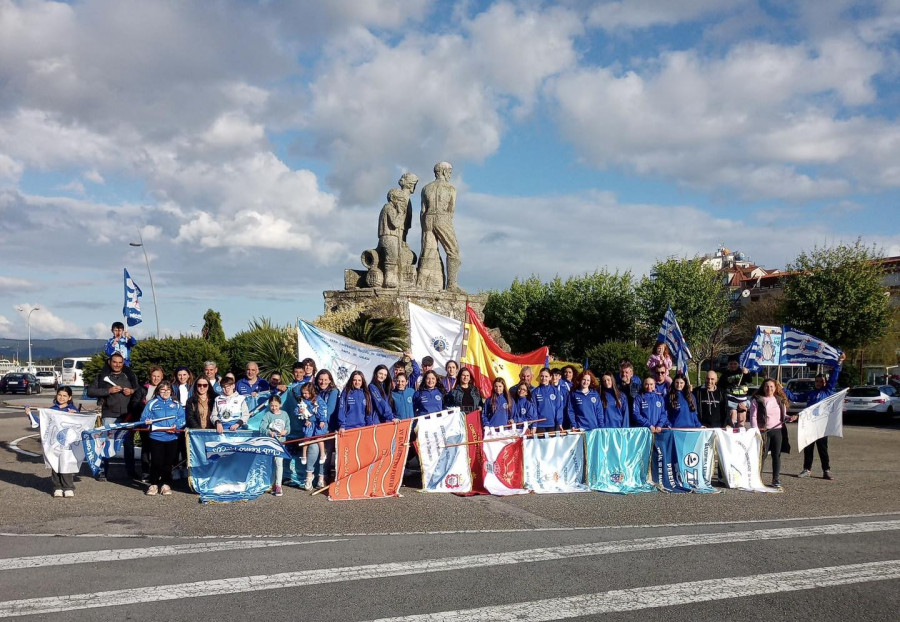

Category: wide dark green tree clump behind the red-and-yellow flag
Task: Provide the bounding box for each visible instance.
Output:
[484,270,637,360]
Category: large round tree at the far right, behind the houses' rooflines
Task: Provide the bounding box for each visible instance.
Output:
[784,239,891,350]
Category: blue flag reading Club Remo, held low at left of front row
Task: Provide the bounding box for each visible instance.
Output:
[185,430,275,503]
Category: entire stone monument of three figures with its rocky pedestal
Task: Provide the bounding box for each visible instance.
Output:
[324,162,487,322]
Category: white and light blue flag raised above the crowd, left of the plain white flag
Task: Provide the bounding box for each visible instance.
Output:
[297,318,402,389]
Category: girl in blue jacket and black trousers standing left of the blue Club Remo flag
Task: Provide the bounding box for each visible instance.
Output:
[141,380,185,496]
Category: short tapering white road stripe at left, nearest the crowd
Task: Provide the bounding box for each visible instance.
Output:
[0,538,342,570]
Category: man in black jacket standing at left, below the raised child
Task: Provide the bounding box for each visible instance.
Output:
[87,352,143,481]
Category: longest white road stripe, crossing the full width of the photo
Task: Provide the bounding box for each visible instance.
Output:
[0,521,900,619]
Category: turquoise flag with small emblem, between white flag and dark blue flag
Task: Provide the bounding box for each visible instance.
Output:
[584,428,656,494]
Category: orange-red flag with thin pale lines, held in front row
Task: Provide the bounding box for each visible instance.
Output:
[328,419,413,501]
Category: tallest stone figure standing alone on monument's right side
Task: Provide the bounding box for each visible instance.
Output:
[416,162,465,293]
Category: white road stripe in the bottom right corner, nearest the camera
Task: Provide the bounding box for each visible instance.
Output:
[362,560,900,622]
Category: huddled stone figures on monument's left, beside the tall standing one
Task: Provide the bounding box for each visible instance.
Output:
[361,173,419,288]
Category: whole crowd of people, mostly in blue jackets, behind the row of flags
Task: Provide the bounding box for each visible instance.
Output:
[33,322,843,496]
